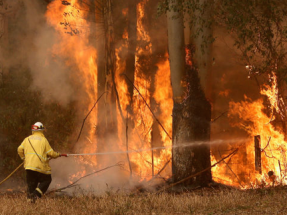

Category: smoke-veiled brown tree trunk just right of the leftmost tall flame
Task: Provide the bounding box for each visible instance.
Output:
[96,0,117,162]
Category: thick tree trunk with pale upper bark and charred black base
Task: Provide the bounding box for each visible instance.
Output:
[167,1,211,186]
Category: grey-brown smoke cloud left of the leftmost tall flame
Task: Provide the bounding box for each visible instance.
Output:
[0,0,74,105]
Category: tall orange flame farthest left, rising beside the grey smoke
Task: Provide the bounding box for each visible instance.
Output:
[46,0,97,162]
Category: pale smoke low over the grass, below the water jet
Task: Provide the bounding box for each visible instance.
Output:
[49,156,131,194]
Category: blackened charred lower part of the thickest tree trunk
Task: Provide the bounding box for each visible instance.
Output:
[172,47,212,186]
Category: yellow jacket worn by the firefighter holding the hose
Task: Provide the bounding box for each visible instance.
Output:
[18,131,60,174]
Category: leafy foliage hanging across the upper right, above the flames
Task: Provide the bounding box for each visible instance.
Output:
[158,0,287,81]
